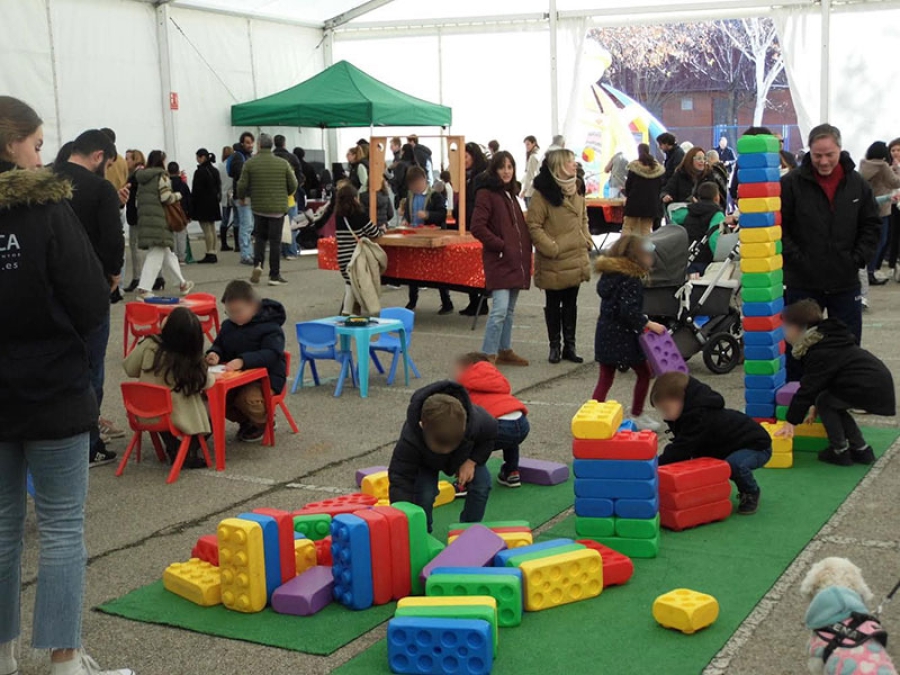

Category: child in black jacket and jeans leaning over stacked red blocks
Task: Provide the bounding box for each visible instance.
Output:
[650,372,772,515]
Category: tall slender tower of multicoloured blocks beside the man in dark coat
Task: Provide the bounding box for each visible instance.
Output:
[737,135,785,420]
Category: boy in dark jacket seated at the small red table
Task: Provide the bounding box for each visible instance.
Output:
[206,281,287,443]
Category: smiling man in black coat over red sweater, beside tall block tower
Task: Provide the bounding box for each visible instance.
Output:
[781,124,881,381]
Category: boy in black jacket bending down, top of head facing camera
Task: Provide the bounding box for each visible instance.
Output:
[388,381,497,532]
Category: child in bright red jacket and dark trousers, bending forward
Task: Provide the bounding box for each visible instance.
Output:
[454,352,531,487]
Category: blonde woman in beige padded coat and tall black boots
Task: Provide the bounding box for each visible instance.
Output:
[525,149,593,363]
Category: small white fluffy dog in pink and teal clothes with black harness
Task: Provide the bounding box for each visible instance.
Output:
[800,557,897,675]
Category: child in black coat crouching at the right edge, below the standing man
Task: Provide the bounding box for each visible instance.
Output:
[776,300,896,466]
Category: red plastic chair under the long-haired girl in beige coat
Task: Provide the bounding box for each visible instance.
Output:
[116,382,213,483]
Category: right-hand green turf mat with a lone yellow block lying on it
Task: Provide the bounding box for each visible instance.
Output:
[335,428,900,675]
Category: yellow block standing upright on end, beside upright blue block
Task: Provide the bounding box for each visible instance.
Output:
[218,518,267,613]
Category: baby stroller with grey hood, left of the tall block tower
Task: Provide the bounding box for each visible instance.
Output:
[644,225,743,374]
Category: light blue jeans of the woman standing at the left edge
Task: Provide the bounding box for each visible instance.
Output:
[0,434,90,649]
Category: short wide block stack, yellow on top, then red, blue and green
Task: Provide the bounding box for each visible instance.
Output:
[572,401,659,558]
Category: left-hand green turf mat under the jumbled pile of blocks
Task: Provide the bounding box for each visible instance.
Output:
[97,459,573,655]
